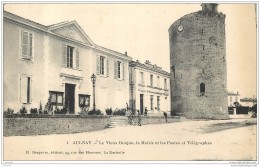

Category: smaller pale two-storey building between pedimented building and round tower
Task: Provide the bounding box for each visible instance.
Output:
[129,61,170,115]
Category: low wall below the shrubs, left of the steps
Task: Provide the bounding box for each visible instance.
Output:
[3,115,110,136]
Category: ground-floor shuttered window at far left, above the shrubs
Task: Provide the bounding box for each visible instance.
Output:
[20,75,32,104]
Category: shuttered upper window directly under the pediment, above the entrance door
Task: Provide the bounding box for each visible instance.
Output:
[62,45,79,69]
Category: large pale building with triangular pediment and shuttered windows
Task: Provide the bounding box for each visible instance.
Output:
[3,11,132,114]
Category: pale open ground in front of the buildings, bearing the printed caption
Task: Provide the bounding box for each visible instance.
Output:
[3,119,257,161]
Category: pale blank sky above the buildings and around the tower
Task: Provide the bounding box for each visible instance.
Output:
[4,3,257,98]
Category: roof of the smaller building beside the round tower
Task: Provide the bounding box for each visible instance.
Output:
[130,60,170,77]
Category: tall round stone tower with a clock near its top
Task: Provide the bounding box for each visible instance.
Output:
[169,3,229,119]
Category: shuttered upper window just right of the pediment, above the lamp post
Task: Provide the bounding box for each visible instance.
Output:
[96,55,109,77]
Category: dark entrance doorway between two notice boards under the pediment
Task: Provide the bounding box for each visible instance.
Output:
[65,84,75,114]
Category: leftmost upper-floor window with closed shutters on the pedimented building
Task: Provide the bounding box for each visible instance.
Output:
[21,30,33,60]
